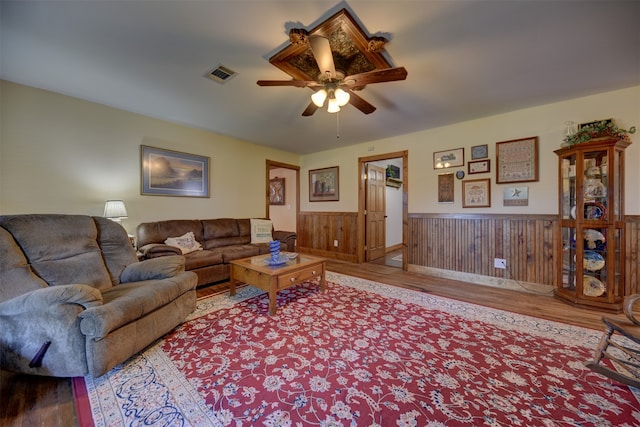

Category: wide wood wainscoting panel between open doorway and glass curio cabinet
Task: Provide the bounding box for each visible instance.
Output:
[407,214,558,286]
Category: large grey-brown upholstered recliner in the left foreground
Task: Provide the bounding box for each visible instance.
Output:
[0,214,197,377]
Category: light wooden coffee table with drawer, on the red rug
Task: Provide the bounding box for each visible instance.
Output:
[229,254,326,316]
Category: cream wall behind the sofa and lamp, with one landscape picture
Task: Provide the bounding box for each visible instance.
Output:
[0,81,299,233]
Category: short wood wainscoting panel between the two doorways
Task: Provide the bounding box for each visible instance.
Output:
[297,212,358,262]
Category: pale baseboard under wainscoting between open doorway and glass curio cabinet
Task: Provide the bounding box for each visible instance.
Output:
[407,264,555,295]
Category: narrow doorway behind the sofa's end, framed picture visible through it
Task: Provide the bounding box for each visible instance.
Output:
[265,160,300,242]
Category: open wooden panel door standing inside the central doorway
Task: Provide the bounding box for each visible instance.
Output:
[365,164,386,261]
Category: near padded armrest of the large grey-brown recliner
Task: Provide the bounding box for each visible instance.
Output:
[0,284,102,316]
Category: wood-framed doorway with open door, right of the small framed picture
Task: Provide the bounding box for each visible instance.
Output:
[358,151,409,271]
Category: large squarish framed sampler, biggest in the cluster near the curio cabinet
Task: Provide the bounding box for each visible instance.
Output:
[496,136,539,184]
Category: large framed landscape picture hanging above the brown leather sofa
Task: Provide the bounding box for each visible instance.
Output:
[140,145,210,197]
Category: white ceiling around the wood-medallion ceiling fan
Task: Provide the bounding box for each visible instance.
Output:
[0,0,640,154]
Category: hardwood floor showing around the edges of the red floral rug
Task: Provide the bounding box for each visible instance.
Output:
[0,253,636,427]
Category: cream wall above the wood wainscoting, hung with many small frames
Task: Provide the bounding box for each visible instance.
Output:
[300,86,640,215]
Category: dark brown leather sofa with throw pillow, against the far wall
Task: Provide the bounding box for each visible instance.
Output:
[136,218,297,286]
